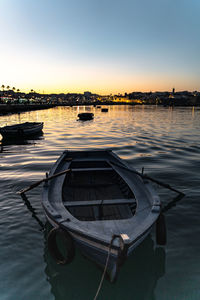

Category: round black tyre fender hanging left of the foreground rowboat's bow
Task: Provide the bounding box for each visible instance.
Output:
[47,228,75,265]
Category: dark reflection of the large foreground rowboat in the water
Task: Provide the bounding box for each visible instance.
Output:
[44,223,165,300]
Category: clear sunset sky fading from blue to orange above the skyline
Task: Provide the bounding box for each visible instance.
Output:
[0,0,200,94]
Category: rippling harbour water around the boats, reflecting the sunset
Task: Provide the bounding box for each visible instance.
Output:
[0,106,200,300]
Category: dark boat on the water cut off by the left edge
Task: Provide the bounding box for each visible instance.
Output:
[0,122,43,139]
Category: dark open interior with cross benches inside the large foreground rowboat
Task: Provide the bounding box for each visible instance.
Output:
[62,163,136,221]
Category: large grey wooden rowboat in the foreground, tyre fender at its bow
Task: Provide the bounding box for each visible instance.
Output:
[42,150,164,281]
